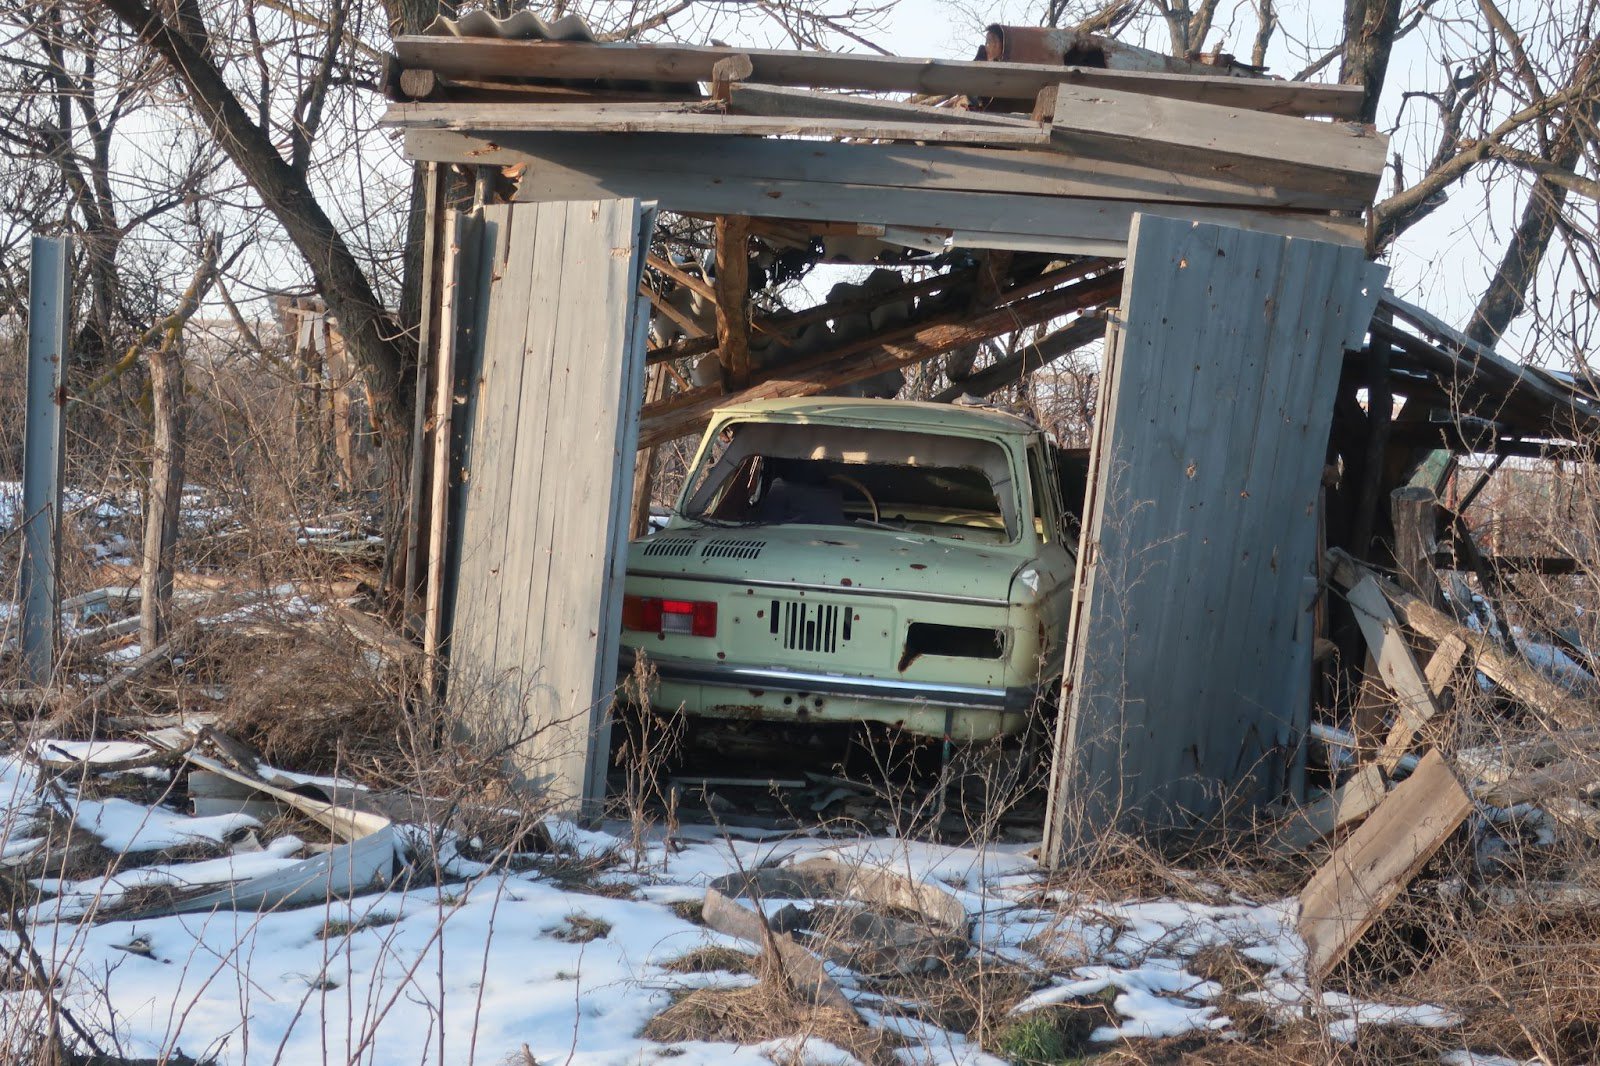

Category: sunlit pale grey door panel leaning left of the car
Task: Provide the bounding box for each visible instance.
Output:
[445,200,654,815]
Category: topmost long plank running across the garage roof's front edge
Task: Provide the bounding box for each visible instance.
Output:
[395,37,1362,118]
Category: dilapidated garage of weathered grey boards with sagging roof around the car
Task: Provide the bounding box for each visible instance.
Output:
[387,13,1597,852]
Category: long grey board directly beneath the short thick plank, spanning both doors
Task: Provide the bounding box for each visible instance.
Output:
[406,130,1366,211]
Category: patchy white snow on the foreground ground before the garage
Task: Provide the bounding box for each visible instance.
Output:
[0,743,1486,1066]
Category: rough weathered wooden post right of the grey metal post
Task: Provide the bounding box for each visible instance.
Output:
[139,344,184,651]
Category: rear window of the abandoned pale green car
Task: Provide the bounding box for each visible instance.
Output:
[682,423,1018,543]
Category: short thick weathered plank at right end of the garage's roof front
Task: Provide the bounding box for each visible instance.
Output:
[1051,85,1389,198]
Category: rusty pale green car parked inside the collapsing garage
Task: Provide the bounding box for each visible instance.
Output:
[622,399,1082,741]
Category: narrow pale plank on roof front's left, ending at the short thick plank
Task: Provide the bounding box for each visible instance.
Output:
[379,104,1050,146]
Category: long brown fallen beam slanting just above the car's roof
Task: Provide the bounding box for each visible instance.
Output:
[638,271,1122,445]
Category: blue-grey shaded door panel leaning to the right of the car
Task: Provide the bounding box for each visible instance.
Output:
[1048,214,1386,855]
